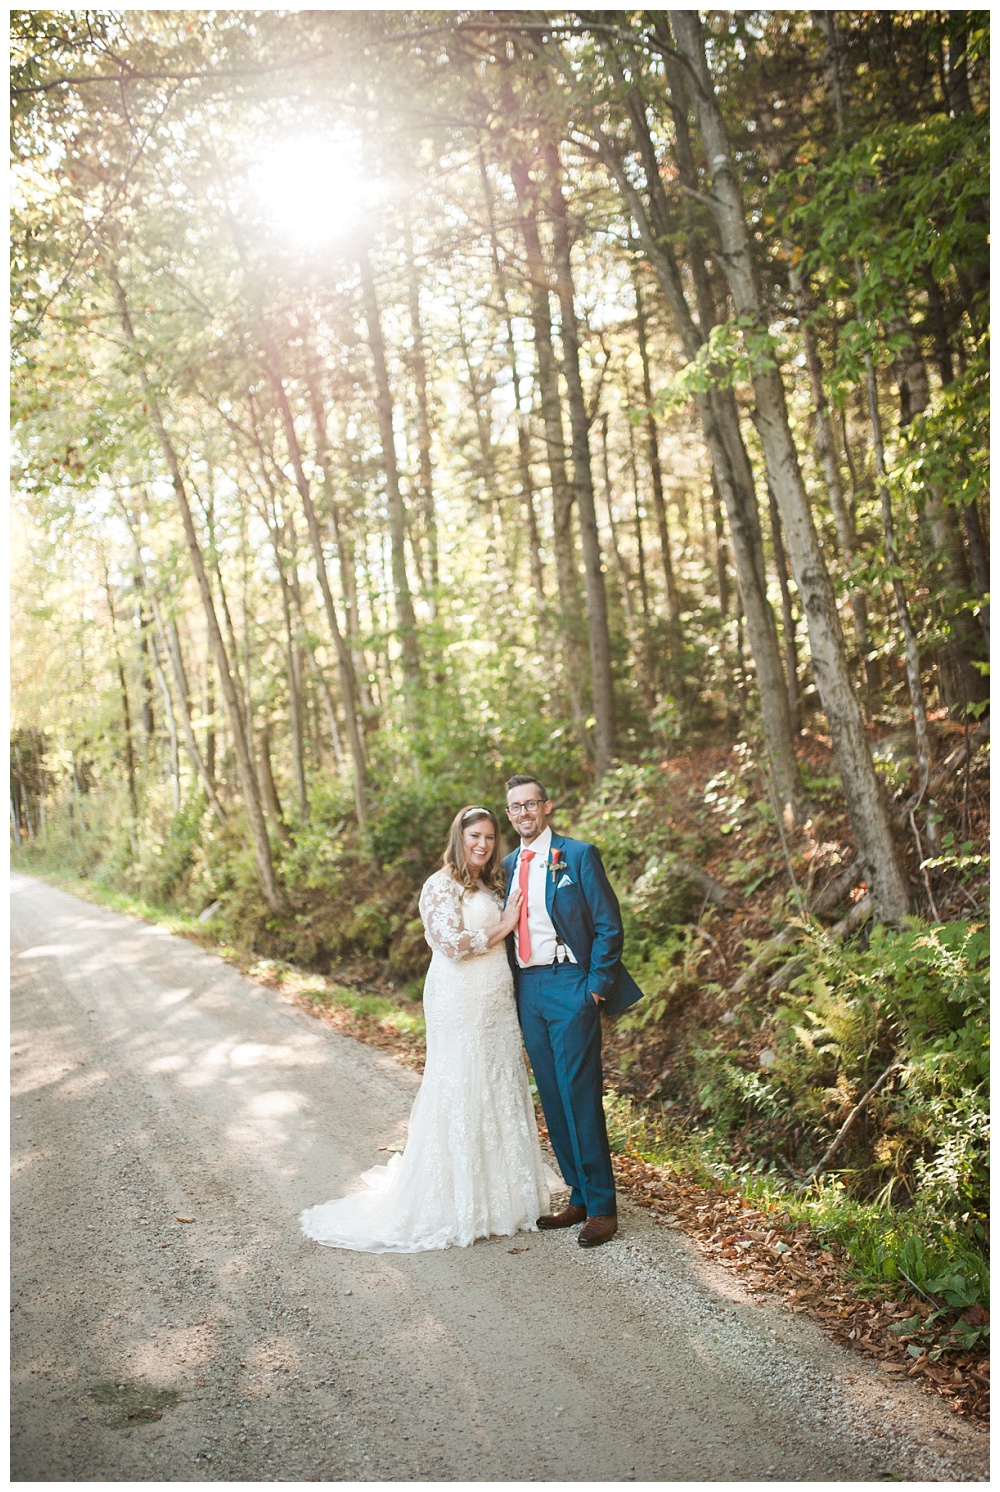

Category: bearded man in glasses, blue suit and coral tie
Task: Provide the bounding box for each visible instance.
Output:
[503,776,642,1249]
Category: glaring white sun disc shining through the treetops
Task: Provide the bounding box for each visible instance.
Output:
[251,134,376,248]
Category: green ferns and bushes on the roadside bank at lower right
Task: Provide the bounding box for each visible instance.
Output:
[650,922,988,1324]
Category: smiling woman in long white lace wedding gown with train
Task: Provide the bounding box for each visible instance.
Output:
[301,807,560,1253]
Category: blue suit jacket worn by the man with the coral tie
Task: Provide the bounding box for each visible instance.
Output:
[503,833,642,1015]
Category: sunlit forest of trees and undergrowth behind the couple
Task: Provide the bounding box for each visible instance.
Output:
[10,9,990,1394]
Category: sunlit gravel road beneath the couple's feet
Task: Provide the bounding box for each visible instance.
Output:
[12,876,987,1482]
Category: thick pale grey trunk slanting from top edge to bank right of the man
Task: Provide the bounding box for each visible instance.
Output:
[670,10,910,922]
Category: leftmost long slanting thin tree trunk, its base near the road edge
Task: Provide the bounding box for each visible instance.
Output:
[110,273,291,916]
